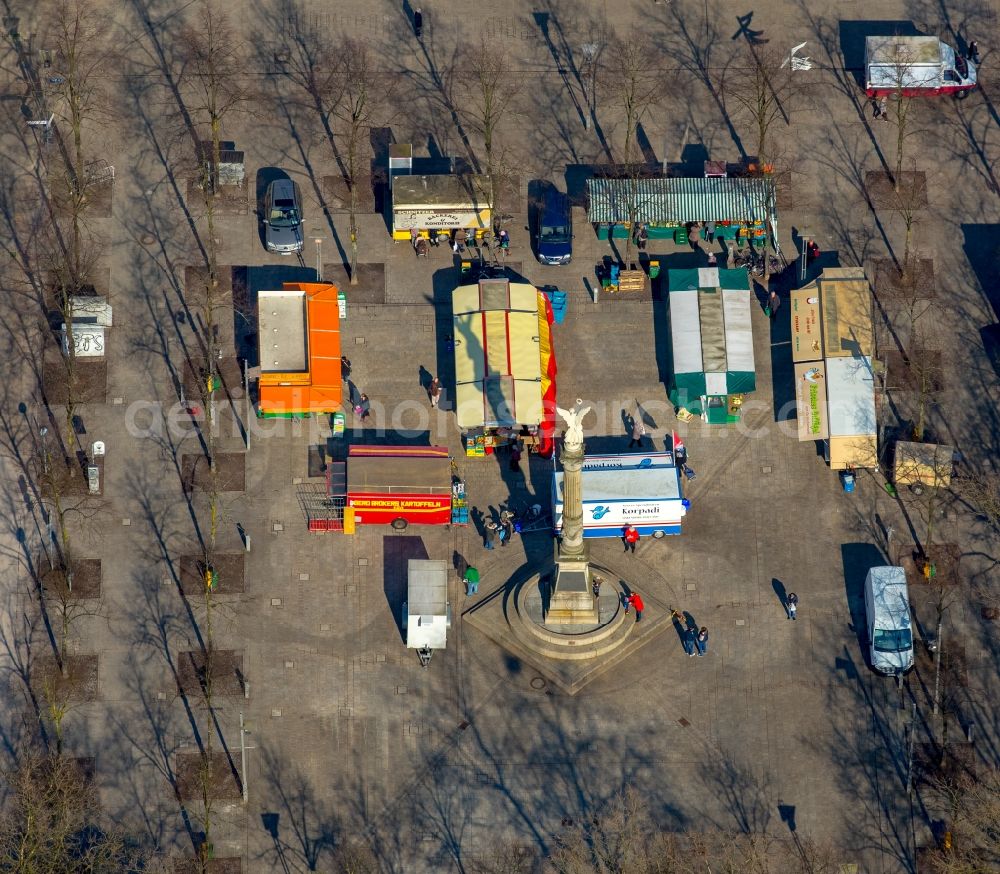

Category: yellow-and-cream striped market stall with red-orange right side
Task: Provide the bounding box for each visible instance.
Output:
[452,276,556,457]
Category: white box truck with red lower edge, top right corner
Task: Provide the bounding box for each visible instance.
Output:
[865,36,976,97]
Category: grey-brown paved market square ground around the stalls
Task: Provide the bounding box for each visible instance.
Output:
[0,0,1000,872]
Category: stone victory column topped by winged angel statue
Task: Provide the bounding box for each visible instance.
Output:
[545,398,599,625]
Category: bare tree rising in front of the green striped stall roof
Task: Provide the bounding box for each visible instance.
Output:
[600,31,663,265]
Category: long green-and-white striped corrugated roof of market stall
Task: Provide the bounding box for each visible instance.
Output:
[587,176,777,224]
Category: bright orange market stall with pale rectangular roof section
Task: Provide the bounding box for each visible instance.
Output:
[257,282,342,418]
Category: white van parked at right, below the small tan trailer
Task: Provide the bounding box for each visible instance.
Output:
[865,567,913,674]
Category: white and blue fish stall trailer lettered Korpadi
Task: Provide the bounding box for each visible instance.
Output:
[552,452,688,538]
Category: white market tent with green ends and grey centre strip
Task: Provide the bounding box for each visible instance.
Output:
[667,267,757,421]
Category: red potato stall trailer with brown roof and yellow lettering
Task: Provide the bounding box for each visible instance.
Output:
[344,446,456,533]
